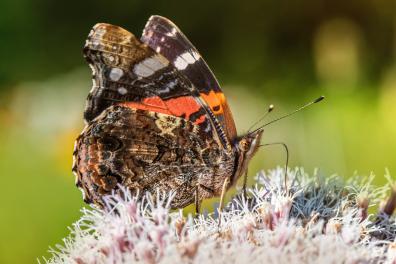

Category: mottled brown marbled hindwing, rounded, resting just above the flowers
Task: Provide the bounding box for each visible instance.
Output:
[73,106,234,208]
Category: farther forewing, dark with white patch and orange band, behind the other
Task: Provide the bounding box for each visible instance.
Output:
[141,16,236,141]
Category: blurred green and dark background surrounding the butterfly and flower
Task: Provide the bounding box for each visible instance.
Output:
[0,0,396,263]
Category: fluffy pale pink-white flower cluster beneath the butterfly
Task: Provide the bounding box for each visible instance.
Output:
[44,168,396,264]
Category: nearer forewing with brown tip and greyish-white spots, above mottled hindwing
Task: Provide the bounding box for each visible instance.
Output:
[84,23,193,122]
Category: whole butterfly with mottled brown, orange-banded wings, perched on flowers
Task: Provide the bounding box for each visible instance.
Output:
[73,16,263,211]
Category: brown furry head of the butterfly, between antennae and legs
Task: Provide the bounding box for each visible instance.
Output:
[231,129,264,184]
